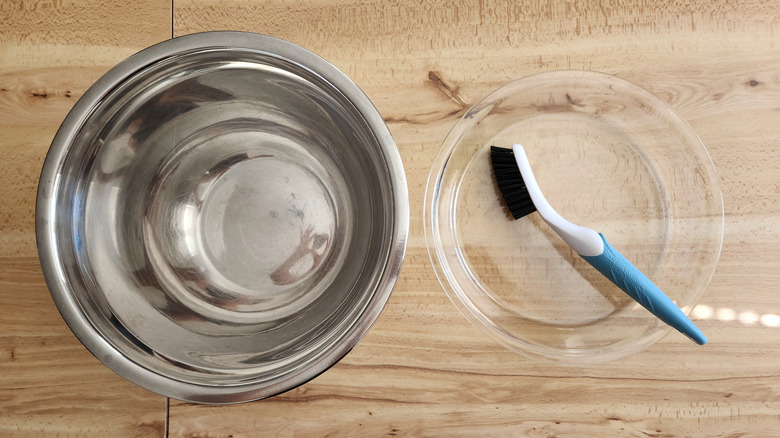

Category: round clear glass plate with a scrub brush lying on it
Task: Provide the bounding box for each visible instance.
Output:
[425,71,723,365]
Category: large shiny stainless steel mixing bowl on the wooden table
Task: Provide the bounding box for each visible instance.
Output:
[36,32,409,403]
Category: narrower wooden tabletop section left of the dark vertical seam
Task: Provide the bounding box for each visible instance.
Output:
[0,0,171,437]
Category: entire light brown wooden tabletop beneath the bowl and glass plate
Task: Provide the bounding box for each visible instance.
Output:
[0,0,780,437]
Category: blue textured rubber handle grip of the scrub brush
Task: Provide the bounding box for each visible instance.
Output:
[580,233,707,345]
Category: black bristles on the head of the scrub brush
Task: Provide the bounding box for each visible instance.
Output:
[490,146,536,219]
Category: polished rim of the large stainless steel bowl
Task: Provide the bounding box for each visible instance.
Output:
[35,31,410,404]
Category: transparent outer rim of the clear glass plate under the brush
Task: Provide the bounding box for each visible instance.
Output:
[423,69,725,366]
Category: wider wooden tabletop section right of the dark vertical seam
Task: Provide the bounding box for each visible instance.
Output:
[170,0,780,437]
